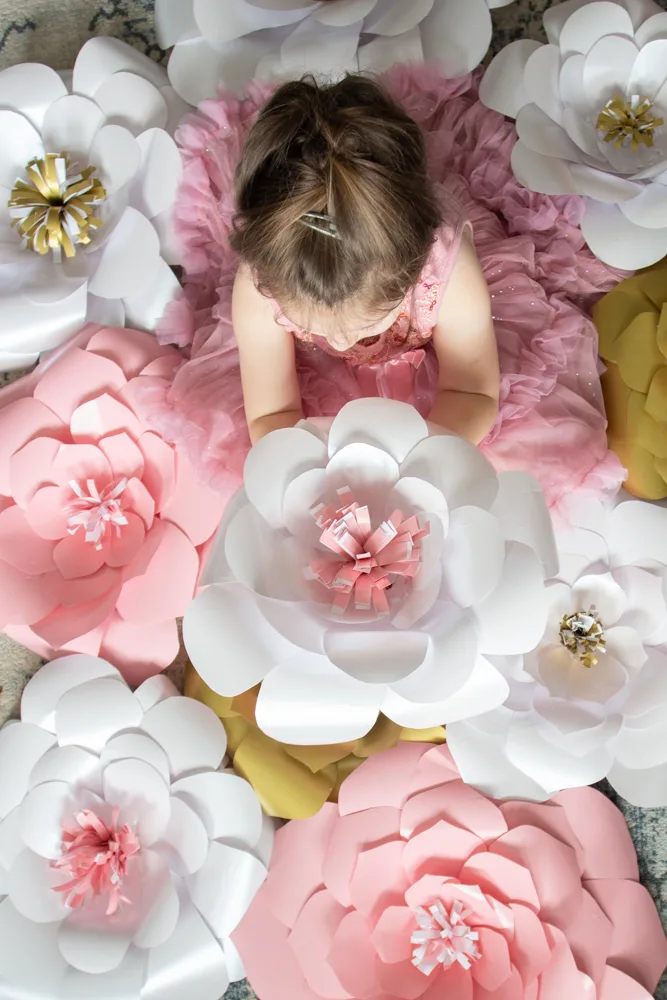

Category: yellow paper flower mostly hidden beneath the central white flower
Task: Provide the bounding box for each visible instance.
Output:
[185,664,445,819]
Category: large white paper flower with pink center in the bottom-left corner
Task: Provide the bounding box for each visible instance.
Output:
[0,655,273,1000]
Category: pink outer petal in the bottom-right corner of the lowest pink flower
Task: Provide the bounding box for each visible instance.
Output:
[586,879,667,995]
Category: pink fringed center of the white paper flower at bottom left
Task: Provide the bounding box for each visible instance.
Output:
[51,809,139,916]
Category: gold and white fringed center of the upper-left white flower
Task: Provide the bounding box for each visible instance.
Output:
[9,153,106,257]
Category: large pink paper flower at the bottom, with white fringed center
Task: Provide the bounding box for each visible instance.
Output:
[233,743,667,1000]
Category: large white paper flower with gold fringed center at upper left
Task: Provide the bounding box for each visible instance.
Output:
[0,38,185,370]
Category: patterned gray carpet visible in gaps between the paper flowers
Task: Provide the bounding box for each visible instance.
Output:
[0,0,667,1000]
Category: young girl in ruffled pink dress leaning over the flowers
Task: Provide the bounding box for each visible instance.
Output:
[151,69,622,505]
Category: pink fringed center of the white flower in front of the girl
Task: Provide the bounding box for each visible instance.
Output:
[309,487,429,615]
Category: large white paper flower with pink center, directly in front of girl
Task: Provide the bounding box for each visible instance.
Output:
[184,399,555,745]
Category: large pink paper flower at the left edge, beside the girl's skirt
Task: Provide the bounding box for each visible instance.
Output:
[0,326,226,682]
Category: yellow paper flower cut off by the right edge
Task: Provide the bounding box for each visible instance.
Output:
[593,258,667,500]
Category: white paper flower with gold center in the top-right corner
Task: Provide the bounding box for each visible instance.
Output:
[480,0,667,269]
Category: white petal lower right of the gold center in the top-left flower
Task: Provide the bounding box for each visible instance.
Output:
[89,208,160,299]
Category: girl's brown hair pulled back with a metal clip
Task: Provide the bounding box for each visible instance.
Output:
[232,75,441,309]
